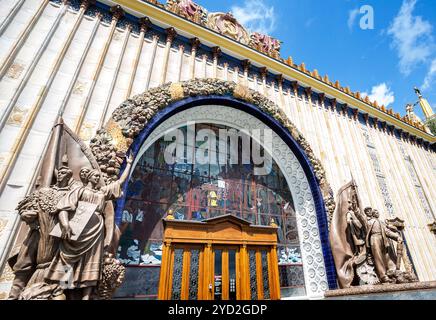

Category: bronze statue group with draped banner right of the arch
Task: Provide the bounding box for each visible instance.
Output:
[330,181,416,288]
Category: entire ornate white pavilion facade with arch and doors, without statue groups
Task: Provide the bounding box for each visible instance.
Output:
[0,0,436,299]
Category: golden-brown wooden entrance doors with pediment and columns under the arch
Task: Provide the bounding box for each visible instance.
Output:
[158,216,280,300]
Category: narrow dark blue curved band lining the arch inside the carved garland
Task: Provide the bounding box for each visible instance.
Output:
[115,95,337,289]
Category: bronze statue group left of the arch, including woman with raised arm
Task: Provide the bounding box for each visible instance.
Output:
[9,148,133,300]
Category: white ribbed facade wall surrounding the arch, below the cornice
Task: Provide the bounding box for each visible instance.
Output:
[0,0,436,294]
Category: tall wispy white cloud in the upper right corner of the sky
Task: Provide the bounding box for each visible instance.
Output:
[388,0,434,75]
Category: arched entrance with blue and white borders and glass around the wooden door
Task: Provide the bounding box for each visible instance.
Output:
[90,81,336,298]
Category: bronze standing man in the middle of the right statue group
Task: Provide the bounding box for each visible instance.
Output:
[366,209,402,283]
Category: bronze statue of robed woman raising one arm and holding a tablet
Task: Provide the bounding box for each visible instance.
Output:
[46,156,133,300]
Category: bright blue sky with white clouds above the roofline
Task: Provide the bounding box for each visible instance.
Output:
[195,0,436,116]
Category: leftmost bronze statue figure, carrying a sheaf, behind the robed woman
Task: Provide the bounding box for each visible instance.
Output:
[9,165,79,300]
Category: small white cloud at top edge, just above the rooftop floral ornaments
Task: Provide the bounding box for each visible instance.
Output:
[232,0,276,34]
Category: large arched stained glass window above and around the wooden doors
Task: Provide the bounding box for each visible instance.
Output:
[117,124,305,299]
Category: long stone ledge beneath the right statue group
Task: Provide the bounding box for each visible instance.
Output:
[324,281,436,300]
